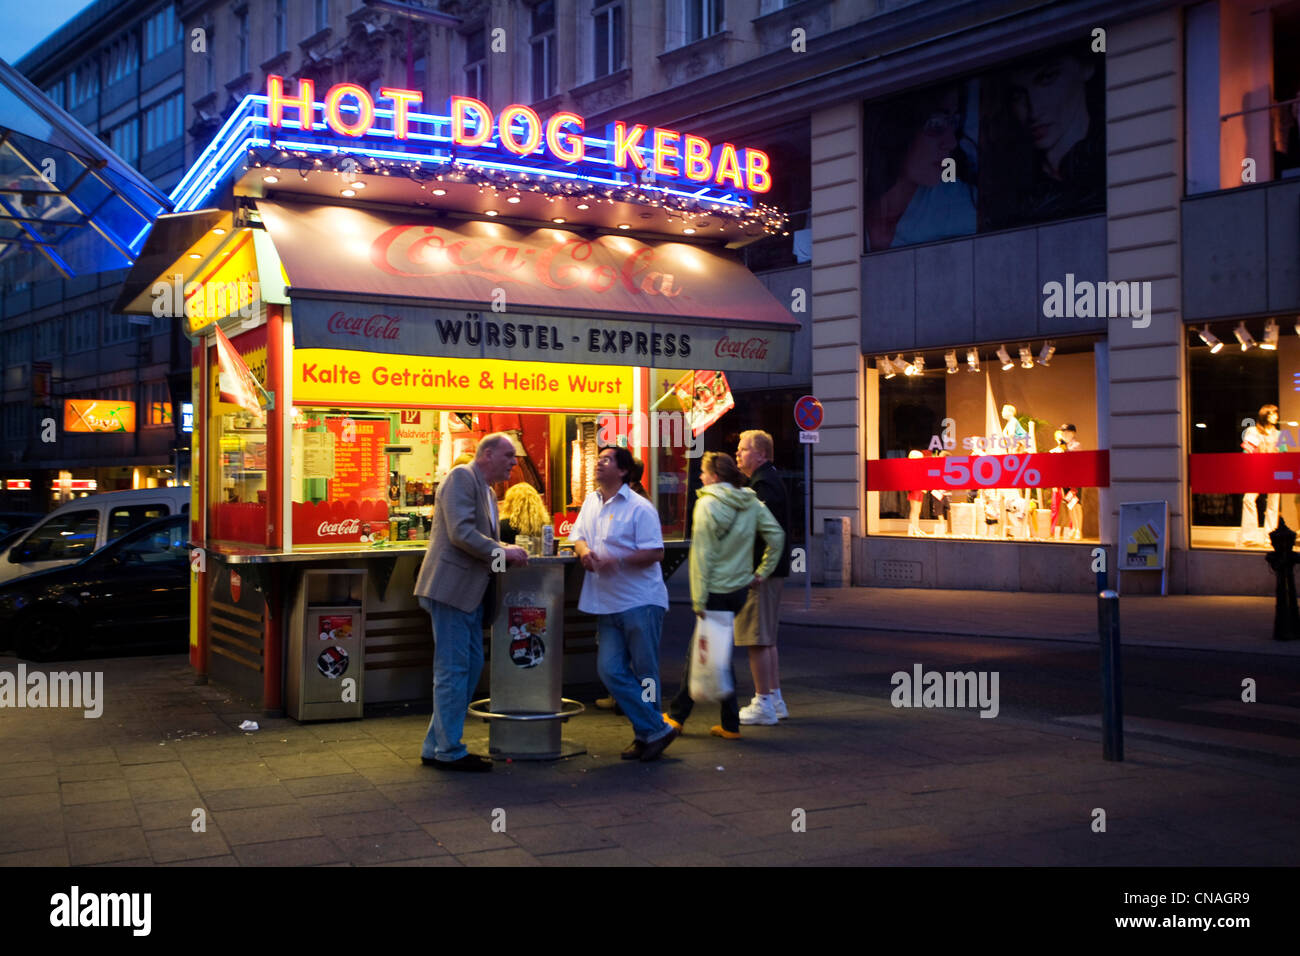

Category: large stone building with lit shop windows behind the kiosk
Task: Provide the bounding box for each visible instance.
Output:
[5,0,1300,593]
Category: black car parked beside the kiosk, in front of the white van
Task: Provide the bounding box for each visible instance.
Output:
[0,515,190,661]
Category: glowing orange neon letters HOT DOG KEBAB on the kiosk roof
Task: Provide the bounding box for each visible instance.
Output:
[267,74,772,193]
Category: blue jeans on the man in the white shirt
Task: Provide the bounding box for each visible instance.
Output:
[595,605,671,741]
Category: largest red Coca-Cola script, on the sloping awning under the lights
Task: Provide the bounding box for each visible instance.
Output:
[371,225,683,298]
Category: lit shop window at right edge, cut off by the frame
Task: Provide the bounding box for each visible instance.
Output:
[1187,316,1300,549]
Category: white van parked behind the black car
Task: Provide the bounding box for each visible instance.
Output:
[0,488,190,584]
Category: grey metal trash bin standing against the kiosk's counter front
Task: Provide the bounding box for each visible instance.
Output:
[285,568,365,721]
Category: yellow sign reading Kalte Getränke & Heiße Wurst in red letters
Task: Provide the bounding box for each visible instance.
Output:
[294,349,633,411]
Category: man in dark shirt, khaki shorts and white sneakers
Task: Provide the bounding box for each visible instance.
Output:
[736,431,790,724]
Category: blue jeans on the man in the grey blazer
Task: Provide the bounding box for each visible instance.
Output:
[420,597,484,761]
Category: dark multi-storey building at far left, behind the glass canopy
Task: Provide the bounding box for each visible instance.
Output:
[0,0,190,511]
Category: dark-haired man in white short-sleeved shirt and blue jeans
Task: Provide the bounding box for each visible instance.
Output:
[569,447,679,761]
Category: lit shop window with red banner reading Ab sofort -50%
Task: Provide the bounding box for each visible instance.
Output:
[867,338,1108,542]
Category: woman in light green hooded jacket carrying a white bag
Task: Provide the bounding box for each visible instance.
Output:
[664,451,785,740]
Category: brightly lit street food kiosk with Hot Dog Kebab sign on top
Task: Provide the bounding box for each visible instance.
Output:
[118,77,798,719]
